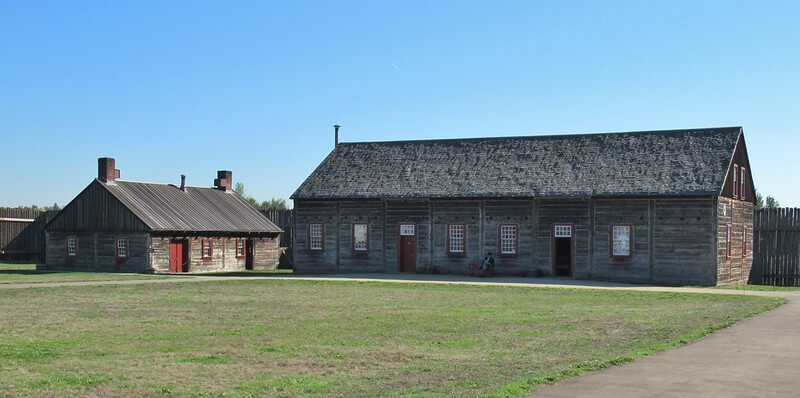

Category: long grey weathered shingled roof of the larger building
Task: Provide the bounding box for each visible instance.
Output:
[292,127,742,199]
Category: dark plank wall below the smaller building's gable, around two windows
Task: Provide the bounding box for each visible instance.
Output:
[45,231,152,272]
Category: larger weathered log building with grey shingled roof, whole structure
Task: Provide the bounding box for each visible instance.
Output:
[292,127,755,285]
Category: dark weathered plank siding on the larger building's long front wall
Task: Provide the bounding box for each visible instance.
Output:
[295,198,724,285]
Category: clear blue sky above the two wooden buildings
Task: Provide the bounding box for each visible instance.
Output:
[0,0,800,206]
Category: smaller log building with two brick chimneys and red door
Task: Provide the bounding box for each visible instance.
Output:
[43,158,283,272]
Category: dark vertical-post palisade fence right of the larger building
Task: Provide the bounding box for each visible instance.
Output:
[750,208,800,286]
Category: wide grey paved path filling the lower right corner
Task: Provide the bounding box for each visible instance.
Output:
[535,293,800,398]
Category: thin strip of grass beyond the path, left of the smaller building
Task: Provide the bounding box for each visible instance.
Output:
[0,263,178,284]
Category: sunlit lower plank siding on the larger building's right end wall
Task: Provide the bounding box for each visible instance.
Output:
[716,197,755,285]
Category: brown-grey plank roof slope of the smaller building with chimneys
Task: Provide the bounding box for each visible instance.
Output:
[100,180,283,233]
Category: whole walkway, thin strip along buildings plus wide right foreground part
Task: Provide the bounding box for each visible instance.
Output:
[0,274,800,397]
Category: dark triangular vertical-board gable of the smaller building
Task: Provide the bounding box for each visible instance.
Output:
[47,181,148,232]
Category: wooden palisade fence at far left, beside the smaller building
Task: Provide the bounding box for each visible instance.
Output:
[0,207,58,261]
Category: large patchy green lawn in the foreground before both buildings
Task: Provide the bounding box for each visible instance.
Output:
[0,279,783,397]
